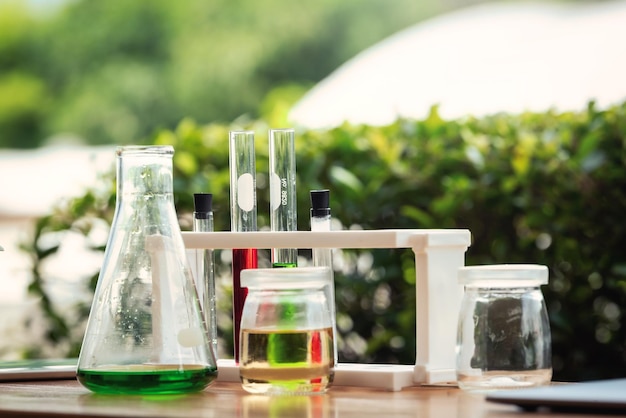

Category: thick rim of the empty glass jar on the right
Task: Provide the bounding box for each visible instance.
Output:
[458,264,548,287]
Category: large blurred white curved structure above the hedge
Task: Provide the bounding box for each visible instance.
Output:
[289,0,626,129]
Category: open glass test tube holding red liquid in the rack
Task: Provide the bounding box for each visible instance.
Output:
[229,131,258,363]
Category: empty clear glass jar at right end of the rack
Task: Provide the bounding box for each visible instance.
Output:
[456,264,552,390]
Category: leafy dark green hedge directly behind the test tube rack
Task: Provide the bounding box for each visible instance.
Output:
[22,103,626,380]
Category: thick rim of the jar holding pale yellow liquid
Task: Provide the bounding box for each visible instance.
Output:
[241,267,331,289]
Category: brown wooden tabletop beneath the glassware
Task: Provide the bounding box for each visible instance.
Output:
[0,380,608,418]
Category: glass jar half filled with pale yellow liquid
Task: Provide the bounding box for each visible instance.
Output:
[239,267,335,395]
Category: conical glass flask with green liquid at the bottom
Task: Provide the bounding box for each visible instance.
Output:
[77,146,217,394]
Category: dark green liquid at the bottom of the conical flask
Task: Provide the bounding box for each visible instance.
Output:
[76,364,217,395]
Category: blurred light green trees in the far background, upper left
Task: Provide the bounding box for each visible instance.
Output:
[0,0,434,148]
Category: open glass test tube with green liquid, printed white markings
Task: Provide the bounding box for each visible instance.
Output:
[269,129,298,267]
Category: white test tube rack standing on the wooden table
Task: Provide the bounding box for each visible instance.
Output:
[183,229,471,391]
